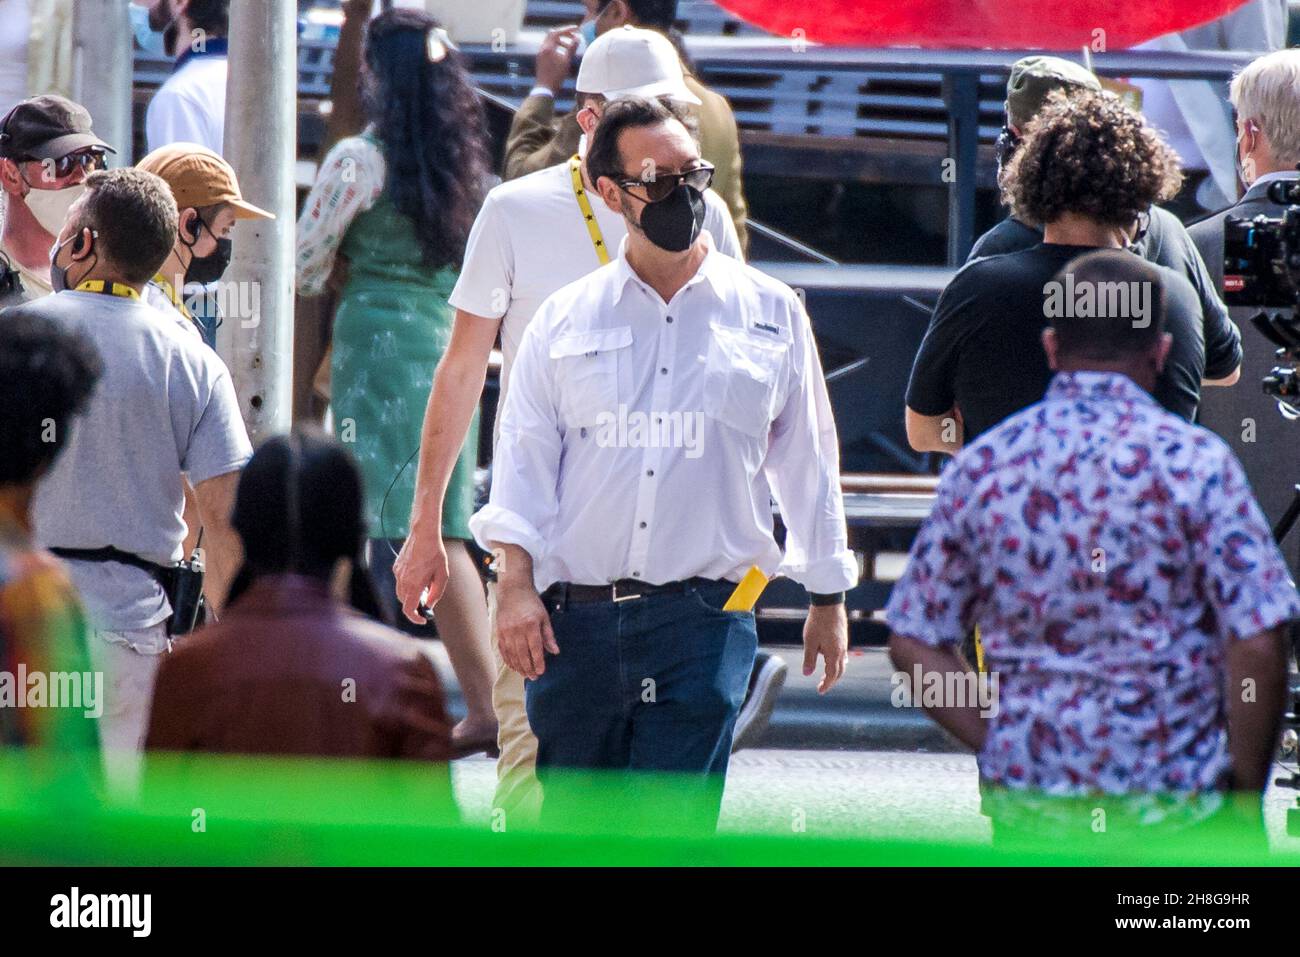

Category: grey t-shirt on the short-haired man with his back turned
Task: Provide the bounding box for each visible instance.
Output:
[26,291,252,631]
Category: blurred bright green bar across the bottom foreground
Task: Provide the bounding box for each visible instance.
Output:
[0,750,1300,867]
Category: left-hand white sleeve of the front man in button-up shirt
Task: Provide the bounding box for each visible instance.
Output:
[469,306,562,568]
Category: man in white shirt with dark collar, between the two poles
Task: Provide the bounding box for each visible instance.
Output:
[144,0,230,153]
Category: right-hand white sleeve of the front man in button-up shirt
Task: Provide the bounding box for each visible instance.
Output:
[766,294,858,594]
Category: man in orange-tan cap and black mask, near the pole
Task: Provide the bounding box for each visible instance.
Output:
[139,143,276,338]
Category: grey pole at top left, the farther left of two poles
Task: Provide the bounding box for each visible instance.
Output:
[73,0,134,166]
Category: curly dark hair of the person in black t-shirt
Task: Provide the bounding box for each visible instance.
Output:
[1002,91,1183,226]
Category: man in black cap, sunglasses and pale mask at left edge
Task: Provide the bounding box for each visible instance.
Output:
[0,95,116,304]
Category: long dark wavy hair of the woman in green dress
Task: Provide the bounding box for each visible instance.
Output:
[361,7,489,269]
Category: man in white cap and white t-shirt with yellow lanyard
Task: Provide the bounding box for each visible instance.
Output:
[390,30,741,818]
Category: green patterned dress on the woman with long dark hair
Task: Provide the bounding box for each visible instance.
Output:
[330,154,478,540]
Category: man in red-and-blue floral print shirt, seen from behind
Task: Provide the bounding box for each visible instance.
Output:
[887,251,1300,832]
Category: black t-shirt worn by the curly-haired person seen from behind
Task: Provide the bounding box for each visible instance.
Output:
[907,243,1242,445]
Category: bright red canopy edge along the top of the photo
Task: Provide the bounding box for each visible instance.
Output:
[718,0,1247,52]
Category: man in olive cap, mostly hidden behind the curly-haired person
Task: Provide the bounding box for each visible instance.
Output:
[966,56,1227,358]
